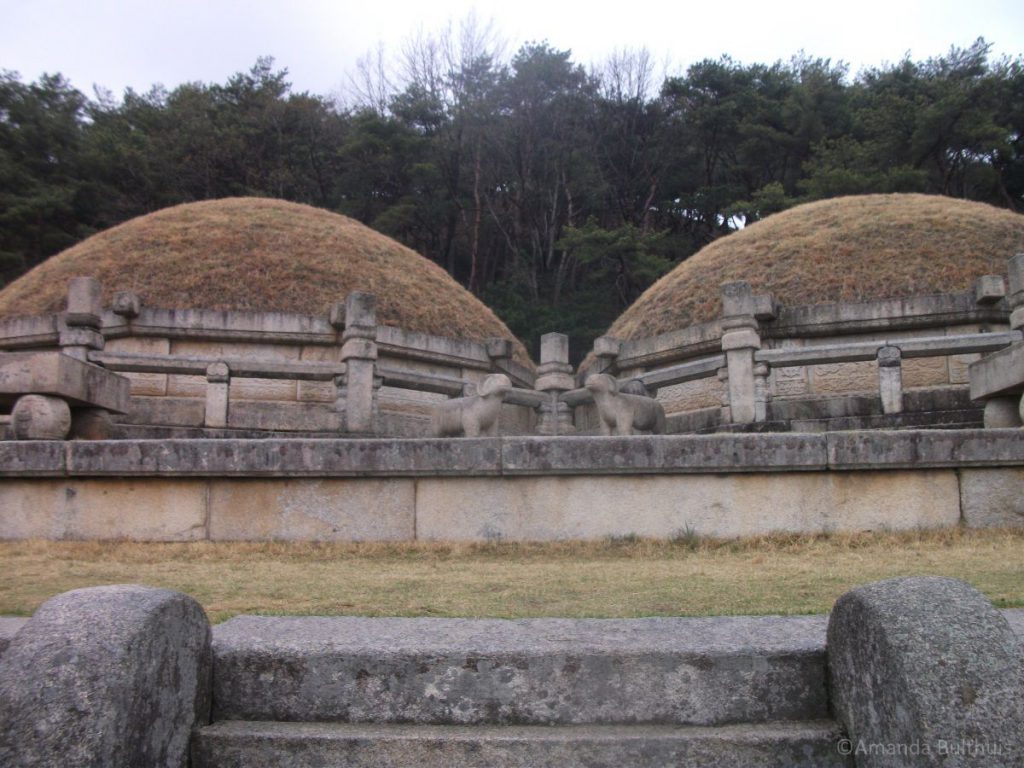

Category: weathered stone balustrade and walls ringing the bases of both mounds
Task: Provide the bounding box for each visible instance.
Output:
[0,255,1024,436]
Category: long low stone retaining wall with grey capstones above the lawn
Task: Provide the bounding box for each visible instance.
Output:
[0,429,1024,541]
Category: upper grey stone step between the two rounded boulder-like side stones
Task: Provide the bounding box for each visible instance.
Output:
[213,616,827,725]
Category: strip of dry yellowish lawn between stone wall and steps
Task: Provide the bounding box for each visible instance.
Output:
[0,528,1024,622]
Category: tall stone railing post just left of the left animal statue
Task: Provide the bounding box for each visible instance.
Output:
[341,291,381,433]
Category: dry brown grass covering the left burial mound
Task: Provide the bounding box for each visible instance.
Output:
[0,198,528,364]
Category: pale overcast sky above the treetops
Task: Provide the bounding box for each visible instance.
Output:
[0,0,1024,101]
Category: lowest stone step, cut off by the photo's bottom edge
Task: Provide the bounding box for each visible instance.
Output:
[191,721,852,768]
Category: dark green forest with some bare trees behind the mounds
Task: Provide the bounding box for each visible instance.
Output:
[0,34,1024,358]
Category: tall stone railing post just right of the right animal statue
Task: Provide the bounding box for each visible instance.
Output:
[722,282,761,424]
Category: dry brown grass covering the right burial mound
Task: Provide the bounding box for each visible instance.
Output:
[608,195,1024,339]
